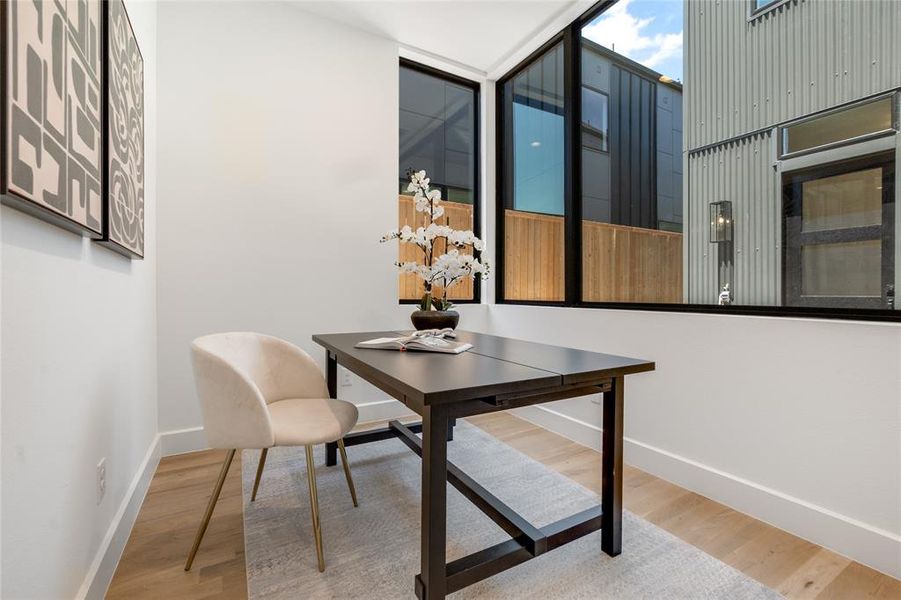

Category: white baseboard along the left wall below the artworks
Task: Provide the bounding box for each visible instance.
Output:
[76,434,160,600]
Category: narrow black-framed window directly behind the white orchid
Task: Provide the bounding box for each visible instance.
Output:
[398,61,479,302]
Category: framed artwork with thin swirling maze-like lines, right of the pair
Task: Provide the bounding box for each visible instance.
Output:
[98,0,144,258]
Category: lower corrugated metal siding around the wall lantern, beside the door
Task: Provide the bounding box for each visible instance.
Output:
[687,132,782,305]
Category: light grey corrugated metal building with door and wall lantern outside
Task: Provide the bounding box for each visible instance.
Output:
[684,0,901,308]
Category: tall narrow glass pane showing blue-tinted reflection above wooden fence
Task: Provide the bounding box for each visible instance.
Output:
[503,44,564,301]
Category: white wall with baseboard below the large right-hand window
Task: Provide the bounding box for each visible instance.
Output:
[489,305,901,577]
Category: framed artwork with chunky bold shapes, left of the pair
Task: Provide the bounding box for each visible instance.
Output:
[0,0,103,238]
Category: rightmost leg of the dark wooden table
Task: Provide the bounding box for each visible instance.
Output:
[601,377,624,556]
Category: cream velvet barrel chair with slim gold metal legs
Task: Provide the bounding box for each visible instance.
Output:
[185,333,358,571]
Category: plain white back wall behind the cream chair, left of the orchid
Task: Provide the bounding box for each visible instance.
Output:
[153,2,492,453]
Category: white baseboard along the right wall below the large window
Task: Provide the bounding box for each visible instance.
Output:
[514,406,901,578]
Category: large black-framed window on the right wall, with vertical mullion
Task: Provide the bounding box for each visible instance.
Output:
[496,0,901,320]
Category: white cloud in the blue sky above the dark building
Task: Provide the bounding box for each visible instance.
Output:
[582,0,682,69]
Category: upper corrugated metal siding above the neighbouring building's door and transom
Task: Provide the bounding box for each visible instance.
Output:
[685,0,901,151]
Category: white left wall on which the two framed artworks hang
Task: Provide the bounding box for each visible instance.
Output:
[0,1,158,598]
